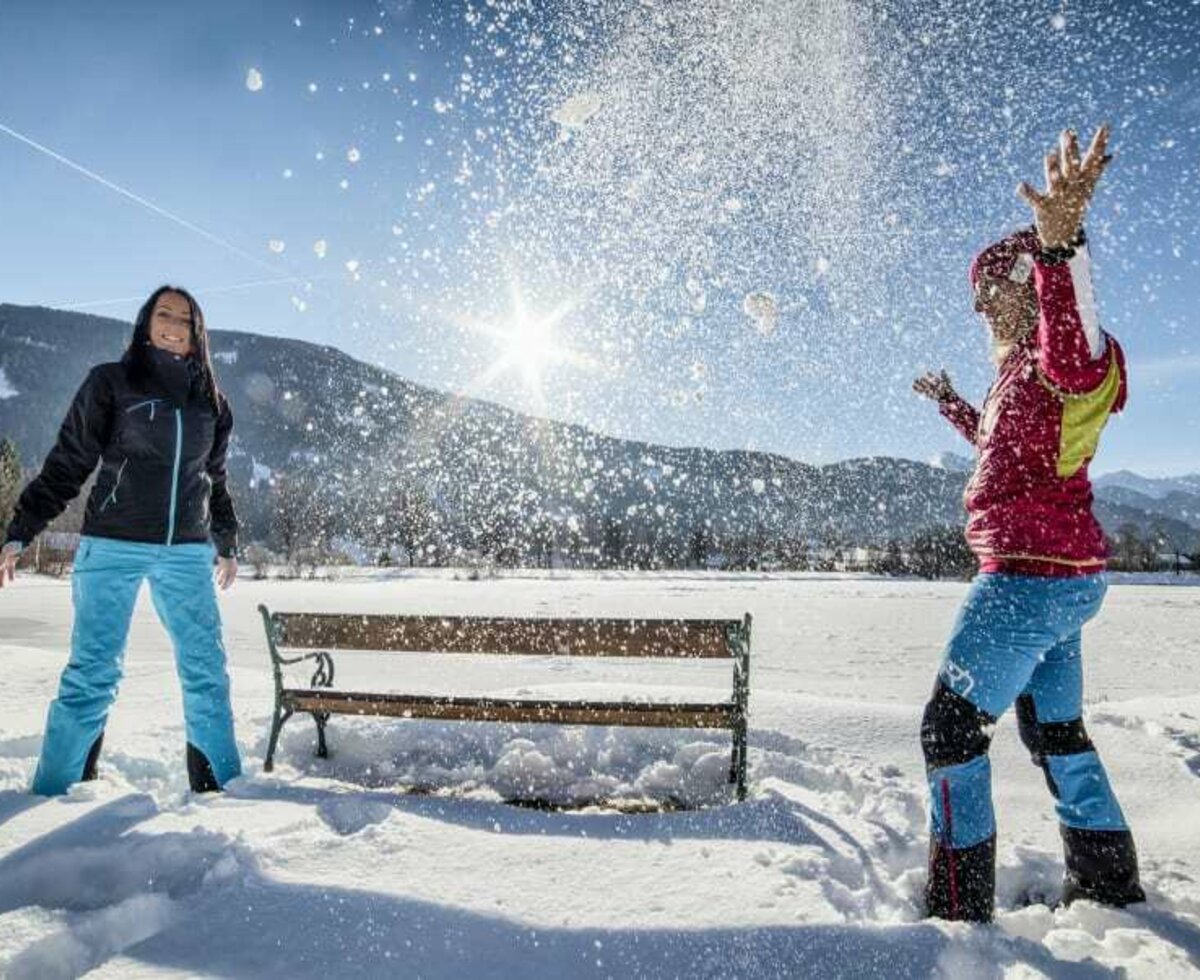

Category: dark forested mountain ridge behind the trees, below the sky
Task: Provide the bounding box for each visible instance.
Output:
[0,303,1200,555]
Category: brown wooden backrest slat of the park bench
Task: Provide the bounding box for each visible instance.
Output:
[271,613,742,660]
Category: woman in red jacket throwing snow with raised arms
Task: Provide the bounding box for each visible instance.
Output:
[913,127,1145,921]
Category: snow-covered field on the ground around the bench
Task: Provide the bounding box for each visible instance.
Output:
[0,573,1200,978]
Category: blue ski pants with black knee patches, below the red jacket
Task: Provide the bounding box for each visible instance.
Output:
[922,573,1128,848]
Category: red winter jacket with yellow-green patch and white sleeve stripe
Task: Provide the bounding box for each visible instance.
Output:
[940,246,1126,576]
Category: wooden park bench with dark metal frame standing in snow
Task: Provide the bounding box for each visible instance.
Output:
[258,606,750,800]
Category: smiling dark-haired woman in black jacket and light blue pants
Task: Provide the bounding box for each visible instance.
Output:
[0,285,241,795]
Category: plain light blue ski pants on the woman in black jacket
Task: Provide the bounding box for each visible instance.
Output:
[32,537,241,796]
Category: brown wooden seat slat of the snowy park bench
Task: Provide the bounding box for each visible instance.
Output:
[282,689,734,728]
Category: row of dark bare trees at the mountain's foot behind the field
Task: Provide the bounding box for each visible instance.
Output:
[0,439,1200,578]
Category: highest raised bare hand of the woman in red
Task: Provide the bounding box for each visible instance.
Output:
[1016,125,1112,248]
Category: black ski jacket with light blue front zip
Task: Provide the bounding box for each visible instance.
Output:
[5,362,238,558]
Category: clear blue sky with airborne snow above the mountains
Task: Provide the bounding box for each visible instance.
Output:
[0,0,1200,474]
